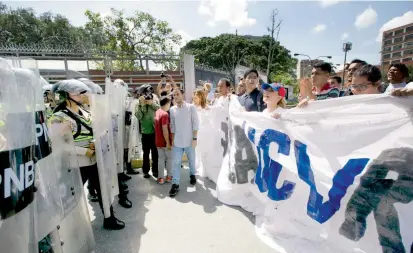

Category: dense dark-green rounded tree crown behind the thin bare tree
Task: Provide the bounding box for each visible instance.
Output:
[181,34,297,81]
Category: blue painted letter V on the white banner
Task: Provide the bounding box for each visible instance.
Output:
[294,141,369,224]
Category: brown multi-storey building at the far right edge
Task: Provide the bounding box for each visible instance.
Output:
[381,23,413,70]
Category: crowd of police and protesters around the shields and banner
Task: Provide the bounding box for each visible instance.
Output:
[37,59,413,234]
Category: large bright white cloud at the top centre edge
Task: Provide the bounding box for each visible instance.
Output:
[198,0,257,28]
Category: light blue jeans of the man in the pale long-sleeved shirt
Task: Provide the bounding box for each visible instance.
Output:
[172,146,195,184]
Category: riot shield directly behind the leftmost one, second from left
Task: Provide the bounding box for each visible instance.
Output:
[11,58,64,246]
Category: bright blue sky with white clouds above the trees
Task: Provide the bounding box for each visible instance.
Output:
[3,0,413,69]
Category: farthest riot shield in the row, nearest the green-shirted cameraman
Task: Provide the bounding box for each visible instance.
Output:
[105,78,127,173]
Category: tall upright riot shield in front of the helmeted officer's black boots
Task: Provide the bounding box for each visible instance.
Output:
[90,94,119,218]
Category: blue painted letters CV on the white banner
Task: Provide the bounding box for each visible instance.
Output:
[242,121,369,224]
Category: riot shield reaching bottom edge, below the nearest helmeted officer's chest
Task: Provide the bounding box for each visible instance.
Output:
[47,122,95,253]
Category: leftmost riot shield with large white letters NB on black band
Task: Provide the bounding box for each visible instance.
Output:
[0,59,38,253]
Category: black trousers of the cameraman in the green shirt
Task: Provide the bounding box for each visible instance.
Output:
[142,134,158,175]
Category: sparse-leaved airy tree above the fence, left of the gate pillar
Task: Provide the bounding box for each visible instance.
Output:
[85,9,182,70]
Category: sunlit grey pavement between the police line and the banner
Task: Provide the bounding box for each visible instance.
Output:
[86,166,274,253]
